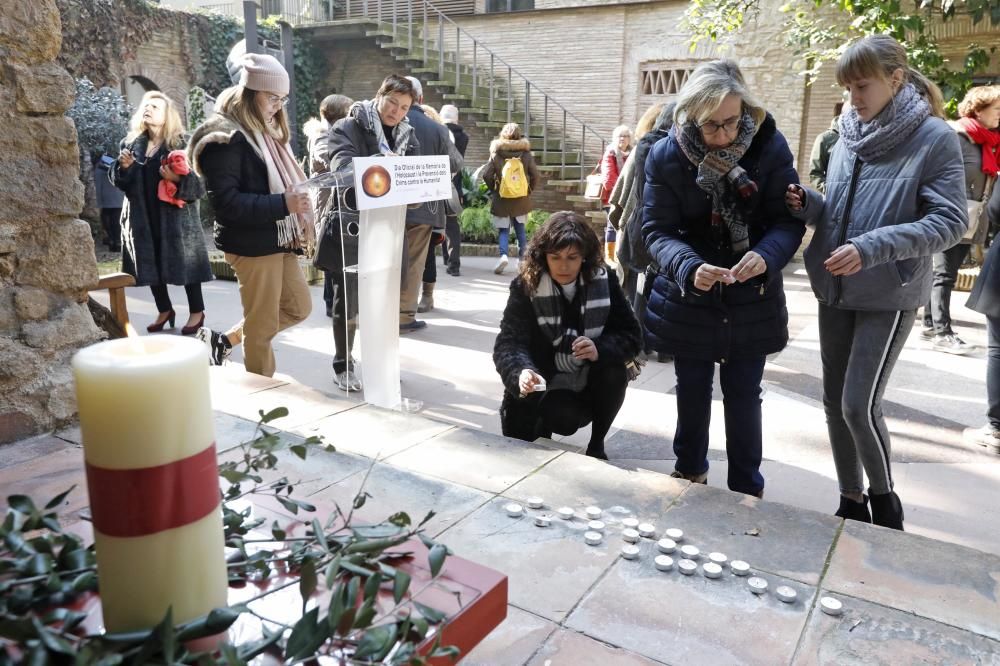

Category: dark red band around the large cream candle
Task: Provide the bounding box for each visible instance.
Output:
[87,442,220,537]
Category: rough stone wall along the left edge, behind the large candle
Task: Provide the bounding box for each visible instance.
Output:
[0,0,100,442]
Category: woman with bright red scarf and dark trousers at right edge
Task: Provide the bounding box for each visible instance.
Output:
[922,86,1000,352]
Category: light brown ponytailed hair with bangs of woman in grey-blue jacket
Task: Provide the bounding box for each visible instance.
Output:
[834,35,945,118]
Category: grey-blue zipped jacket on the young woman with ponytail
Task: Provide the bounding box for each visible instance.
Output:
[796,116,969,311]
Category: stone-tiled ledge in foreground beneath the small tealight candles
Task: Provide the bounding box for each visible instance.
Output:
[0,364,1000,666]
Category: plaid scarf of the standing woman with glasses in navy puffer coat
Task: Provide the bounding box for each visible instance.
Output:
[673,109,758,255]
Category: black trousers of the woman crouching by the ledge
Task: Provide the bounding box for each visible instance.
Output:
[501,360,628,451]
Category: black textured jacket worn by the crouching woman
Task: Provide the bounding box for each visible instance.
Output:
[493,272,642,398]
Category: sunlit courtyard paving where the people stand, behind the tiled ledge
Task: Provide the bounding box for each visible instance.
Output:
[94,257,1000,553]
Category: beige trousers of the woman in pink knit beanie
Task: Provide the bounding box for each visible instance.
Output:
[226,252,312,377]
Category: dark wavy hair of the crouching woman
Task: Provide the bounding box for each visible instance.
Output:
[518,210,602,296]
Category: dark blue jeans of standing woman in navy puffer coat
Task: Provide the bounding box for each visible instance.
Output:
[674,356,765,495]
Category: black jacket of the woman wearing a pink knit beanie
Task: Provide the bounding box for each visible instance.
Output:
[188,114,290,257]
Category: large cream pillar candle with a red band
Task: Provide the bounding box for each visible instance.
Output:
[73,336,227,632]
